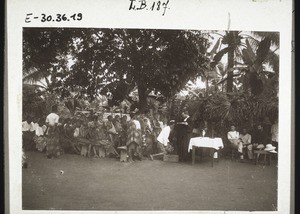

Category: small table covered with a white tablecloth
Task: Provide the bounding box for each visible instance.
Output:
[188,137,224,166]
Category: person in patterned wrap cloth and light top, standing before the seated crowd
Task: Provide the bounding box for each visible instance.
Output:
[126,114,143,161]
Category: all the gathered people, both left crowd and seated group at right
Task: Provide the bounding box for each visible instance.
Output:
[22,107,278,167]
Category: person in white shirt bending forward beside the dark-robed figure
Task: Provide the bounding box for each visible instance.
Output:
[150,120,175,160]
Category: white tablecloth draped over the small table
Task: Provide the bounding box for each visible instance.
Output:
[188,137,224,151]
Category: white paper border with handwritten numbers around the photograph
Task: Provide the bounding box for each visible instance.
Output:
[5,0,293,213]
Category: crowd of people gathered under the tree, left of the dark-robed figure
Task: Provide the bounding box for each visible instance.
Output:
[22,108,178,166]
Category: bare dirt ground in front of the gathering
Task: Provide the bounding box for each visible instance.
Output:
[22,151,277,211]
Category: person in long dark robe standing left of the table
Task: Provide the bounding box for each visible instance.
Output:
[177,111,192,161]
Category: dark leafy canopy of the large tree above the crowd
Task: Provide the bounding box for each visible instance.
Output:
[24,28,209,108]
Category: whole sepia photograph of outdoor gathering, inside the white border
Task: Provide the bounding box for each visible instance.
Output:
[20,28,281,211]
